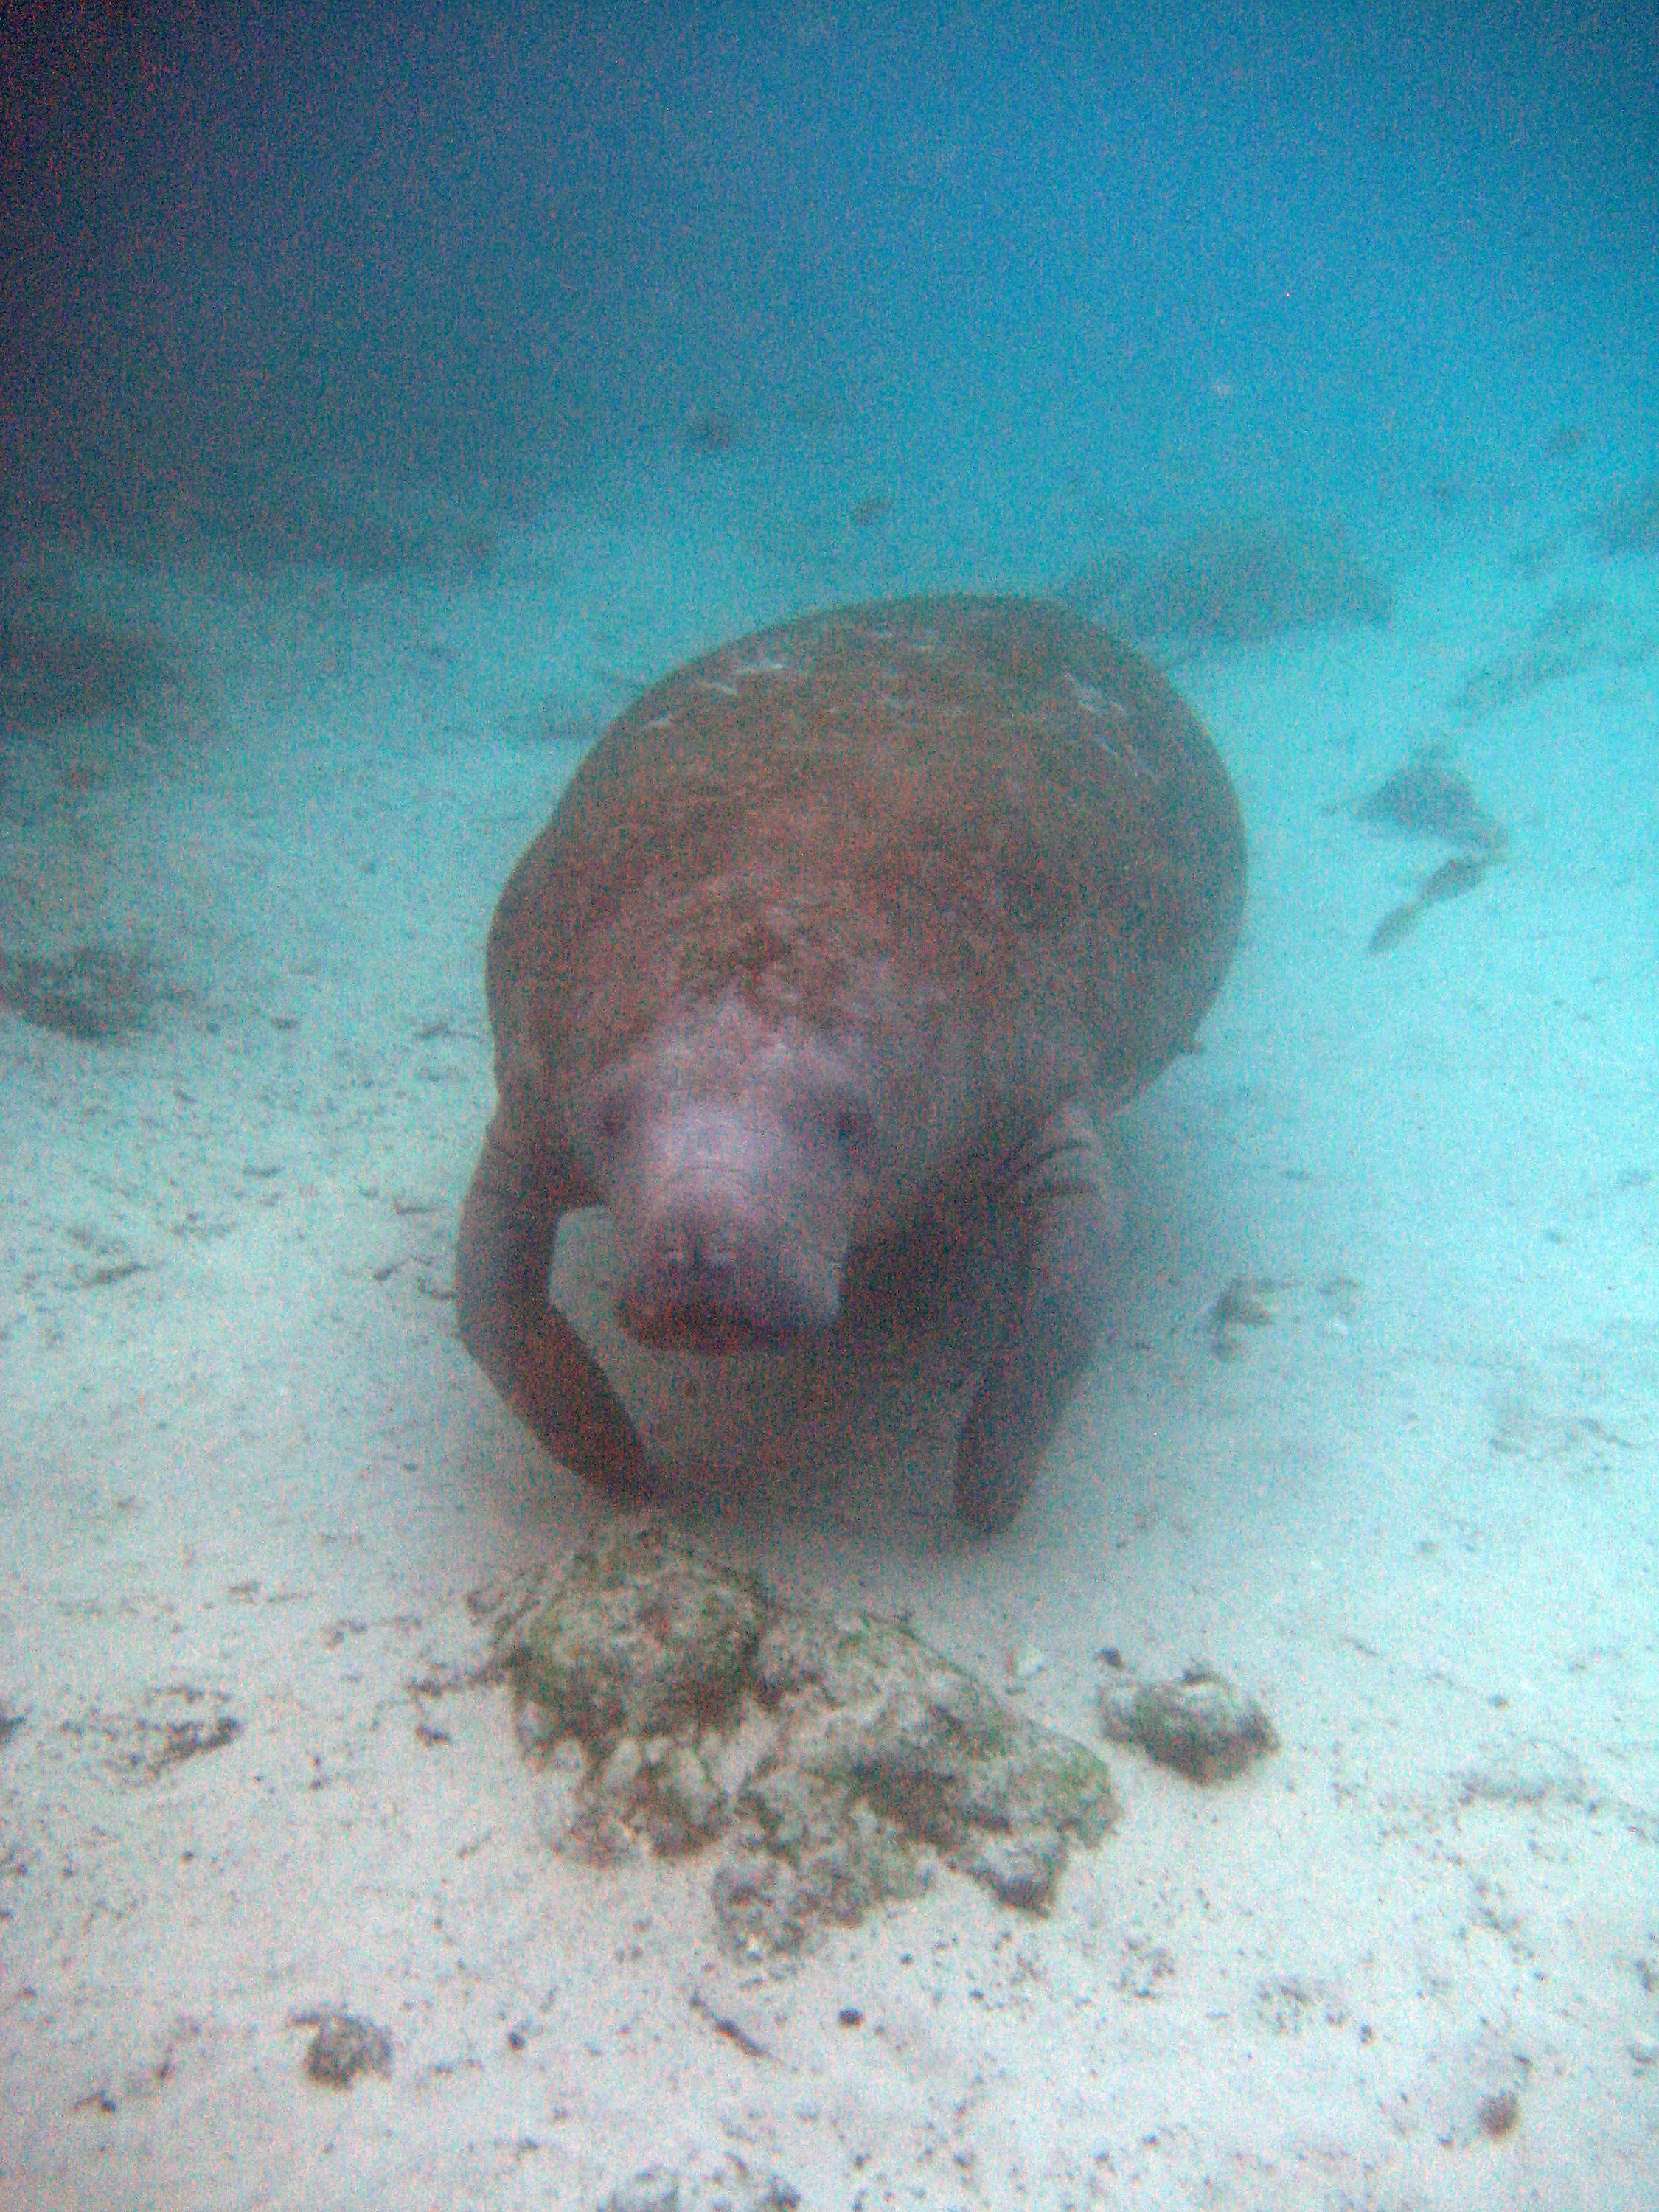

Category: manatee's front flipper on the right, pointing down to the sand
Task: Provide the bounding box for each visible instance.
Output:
[956,1108,1115,1535]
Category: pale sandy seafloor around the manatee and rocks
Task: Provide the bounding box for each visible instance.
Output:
[0,422,1659,2212]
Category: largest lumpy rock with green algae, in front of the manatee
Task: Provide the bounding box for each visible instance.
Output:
[504,1524,1117,1955]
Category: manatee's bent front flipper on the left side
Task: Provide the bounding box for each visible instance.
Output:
[456,1102,655,1504]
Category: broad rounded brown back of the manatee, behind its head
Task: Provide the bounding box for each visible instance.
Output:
[489,595,1245,1099]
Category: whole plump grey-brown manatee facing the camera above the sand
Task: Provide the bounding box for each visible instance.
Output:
[456,595,1245,1533]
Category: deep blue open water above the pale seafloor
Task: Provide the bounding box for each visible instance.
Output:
[2,4,1659,546]
